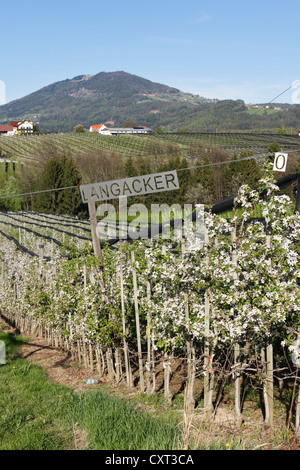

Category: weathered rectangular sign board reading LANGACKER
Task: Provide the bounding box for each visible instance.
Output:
[80,170,179,202]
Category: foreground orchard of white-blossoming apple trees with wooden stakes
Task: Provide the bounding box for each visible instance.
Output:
[0,163,300,448]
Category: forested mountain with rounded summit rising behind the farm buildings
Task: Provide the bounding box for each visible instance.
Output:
[0,72,300,132]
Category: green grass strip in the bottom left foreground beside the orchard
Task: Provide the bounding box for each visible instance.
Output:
[0,331,180,450]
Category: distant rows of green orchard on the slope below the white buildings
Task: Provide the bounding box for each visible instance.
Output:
[0,133,300,162]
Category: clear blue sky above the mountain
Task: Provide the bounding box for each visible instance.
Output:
[0,0,300,103]
